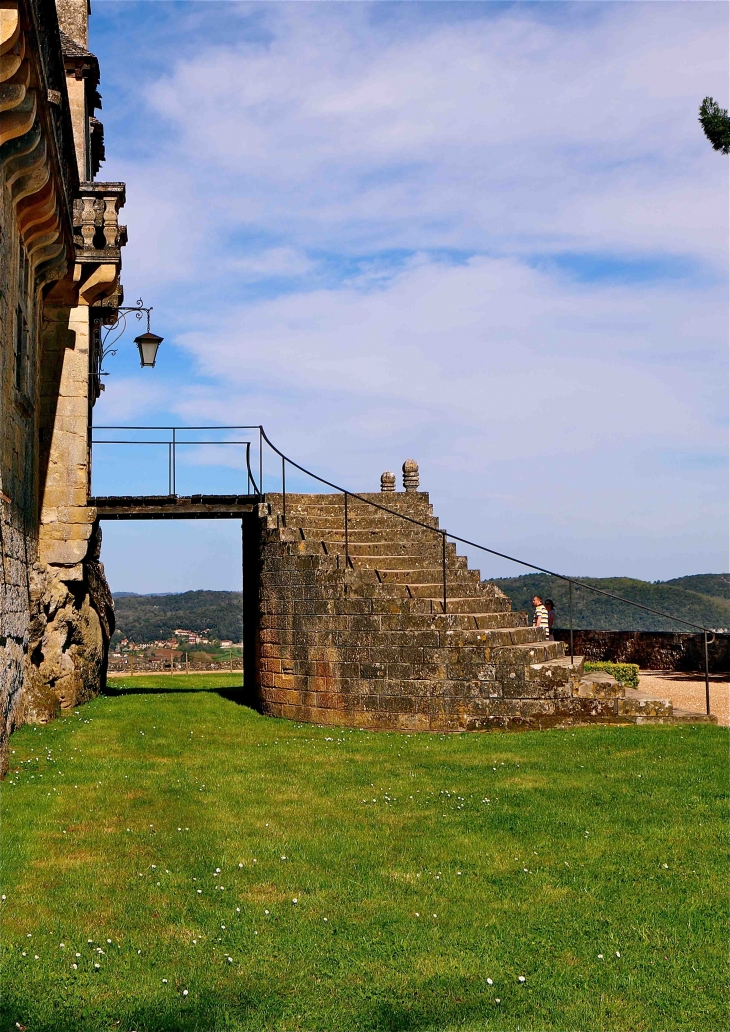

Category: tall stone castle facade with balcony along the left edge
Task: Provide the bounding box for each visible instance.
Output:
[0,0,126,767]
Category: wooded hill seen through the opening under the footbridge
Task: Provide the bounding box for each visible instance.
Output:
[114,591,243,642]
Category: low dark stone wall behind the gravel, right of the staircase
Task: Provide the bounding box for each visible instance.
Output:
[553,627,730,674]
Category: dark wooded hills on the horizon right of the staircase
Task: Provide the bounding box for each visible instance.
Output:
[494,574,730,631]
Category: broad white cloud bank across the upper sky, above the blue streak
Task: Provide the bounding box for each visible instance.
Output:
[141,4,727,261]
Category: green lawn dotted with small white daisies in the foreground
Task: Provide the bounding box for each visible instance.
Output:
[0,674,730,1032]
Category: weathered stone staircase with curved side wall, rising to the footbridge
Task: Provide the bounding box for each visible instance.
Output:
[250,490,706,731]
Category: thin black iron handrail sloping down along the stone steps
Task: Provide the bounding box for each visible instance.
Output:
[259,425,715,715]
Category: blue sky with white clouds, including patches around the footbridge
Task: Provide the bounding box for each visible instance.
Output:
[90,0,728,591]
